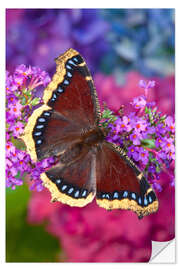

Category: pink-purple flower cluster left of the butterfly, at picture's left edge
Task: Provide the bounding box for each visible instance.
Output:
[6,65,54,190]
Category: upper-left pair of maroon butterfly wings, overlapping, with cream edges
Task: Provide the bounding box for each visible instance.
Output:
[22,49,100,160]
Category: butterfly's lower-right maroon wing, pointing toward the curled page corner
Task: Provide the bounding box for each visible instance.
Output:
[96,142,158,217]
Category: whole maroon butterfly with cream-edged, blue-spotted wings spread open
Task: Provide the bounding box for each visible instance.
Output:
[23,49,158,218]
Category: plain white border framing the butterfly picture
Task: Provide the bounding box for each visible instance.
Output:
[0,0,180,270]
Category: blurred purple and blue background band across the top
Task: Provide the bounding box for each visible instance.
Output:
[6,9,174,76]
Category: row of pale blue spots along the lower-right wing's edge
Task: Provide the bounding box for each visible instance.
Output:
[101,191,153,206]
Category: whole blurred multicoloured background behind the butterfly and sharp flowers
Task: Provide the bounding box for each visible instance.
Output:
[6,9,175,262]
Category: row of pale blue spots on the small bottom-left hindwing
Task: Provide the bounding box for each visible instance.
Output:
[55,178,88,198]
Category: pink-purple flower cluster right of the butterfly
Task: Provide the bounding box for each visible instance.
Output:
[102,80,175,190]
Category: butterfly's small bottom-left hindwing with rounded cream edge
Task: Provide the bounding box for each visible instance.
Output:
[41,151,96,207]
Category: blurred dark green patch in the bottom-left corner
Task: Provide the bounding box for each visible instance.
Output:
[6,185,60,262]
